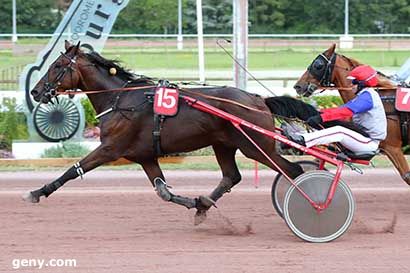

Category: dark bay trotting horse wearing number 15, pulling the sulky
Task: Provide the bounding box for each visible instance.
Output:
[24,42,302,223]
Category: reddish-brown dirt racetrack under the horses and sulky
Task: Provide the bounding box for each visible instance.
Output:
[0,169,410,273]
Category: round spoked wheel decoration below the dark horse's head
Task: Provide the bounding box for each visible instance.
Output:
[33,98,80,142]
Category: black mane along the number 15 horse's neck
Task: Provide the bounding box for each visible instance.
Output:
[85,51,153,83]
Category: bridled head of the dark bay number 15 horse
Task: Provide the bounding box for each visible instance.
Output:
[30,41,82,103]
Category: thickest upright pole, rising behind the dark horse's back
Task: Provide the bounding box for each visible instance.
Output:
[233,0,248,90]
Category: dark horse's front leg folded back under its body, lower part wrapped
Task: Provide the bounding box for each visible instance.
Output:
[141,160,198,209]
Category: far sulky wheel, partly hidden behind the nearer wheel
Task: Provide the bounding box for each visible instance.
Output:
[271,160,326,218]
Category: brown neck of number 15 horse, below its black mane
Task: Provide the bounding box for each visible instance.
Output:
[80,69,126,114]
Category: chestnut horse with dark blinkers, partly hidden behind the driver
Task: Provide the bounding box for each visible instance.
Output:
[294,44,410,185]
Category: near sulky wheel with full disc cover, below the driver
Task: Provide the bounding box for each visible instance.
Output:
[283,170,355,243]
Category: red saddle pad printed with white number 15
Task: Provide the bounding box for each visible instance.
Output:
[154,87,179,116]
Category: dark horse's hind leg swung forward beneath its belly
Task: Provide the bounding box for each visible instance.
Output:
[194,145,241,225]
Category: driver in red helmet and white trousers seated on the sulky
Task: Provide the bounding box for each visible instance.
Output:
[284,65,387,153]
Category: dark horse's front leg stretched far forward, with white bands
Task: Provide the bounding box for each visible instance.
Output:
[23,144,120,203]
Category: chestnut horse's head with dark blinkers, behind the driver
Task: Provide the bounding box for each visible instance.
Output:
[293,44,358,97]
